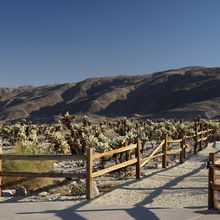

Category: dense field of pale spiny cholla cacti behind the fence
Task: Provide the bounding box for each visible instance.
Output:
[0,112,220,164]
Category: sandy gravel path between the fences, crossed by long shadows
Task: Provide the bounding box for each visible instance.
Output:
[92,143,220,208]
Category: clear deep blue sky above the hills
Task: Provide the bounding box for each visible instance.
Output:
[0,0,220,87]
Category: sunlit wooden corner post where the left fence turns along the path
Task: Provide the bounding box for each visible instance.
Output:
[86,147,93,199]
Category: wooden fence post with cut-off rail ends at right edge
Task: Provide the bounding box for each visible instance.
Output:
[208,153,220,209]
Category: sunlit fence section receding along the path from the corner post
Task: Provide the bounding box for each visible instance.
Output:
[86,129,214,199]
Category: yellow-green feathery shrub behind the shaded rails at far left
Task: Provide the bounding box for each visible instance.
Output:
[3,141,53,190]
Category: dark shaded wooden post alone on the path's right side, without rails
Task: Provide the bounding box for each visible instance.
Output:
[208,153,216,209]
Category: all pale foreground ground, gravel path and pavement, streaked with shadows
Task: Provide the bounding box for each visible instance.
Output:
[0,142,220,219]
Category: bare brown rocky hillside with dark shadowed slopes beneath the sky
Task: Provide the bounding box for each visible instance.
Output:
[0,67,220,121]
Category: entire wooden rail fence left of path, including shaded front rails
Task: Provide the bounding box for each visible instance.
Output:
[0,129,214,199]
